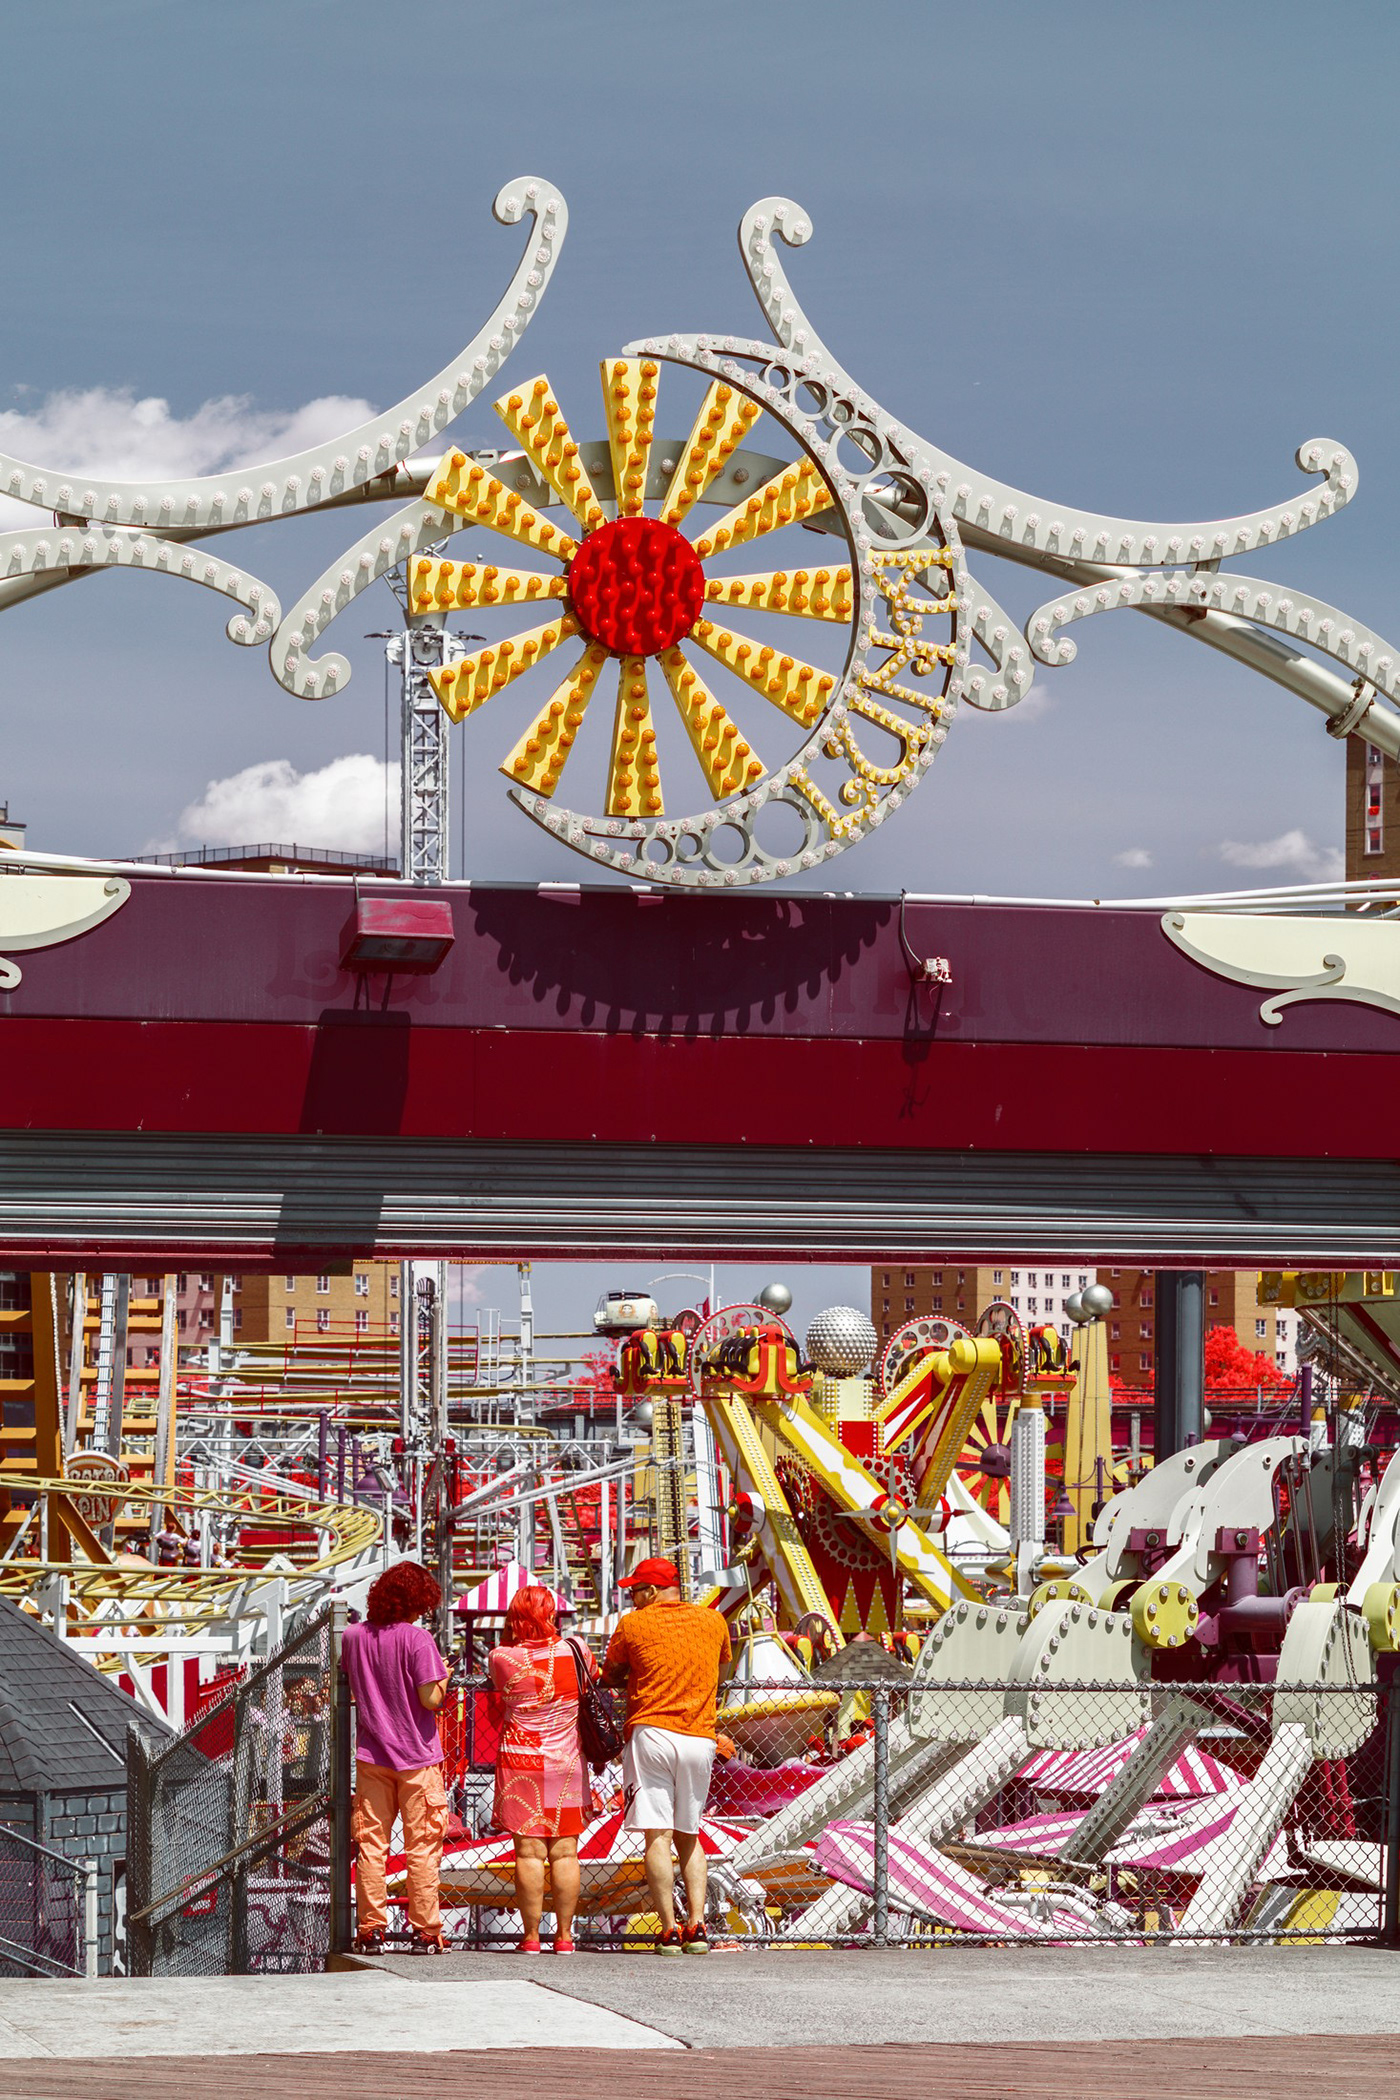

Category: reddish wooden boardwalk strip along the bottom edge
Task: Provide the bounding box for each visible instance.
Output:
[0,2035,1400,2100]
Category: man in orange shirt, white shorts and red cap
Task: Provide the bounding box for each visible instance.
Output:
[602,1560,730,1955]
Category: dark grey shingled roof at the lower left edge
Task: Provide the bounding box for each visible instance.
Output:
[0,1598,174,1793]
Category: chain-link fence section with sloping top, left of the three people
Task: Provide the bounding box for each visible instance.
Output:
[126,1613,351,1976]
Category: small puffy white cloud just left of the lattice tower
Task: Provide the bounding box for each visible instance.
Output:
[178,752,399,853]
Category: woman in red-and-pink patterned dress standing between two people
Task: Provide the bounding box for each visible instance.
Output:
[489,1588,598,1955]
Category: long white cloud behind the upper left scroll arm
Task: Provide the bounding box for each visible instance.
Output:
[0,386,374,531]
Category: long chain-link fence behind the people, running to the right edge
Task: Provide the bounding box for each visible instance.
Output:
[419,1676,1400,1949]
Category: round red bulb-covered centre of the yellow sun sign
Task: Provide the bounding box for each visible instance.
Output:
[569,519,705,655]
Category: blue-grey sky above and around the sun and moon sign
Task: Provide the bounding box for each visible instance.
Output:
[0,0,1400,1310]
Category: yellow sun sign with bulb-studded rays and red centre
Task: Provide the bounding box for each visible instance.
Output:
[409,357,940,821]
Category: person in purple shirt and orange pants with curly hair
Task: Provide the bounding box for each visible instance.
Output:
[340,1560,447,1955]
